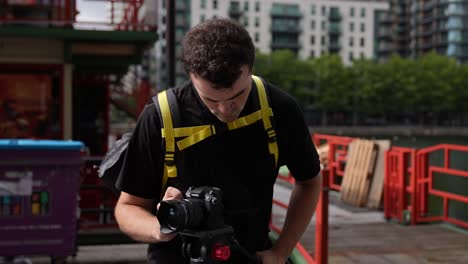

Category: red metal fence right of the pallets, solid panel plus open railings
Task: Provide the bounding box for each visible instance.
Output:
[385,144,468,228]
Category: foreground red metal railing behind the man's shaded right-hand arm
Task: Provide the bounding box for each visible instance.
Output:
[270,169,329,264]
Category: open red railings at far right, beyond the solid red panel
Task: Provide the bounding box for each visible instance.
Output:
[412,144,468,228]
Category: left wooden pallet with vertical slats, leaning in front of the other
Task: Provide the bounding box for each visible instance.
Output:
[341,139,377,206]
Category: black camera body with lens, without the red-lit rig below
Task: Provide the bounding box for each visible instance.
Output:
[157,186,224,234]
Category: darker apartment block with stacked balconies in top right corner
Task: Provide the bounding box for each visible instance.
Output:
[378,0,468,63]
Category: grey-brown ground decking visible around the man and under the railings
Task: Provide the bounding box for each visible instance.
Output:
[0,184,468,264]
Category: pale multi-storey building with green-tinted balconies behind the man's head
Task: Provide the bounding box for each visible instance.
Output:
[155,0,389,89]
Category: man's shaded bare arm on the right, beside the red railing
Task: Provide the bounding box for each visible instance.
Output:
[260,173,322,264]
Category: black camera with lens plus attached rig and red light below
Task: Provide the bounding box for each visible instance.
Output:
[157,186,258,264]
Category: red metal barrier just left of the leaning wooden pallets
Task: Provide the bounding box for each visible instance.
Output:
[312,134,355,191]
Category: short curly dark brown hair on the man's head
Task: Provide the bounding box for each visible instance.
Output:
[181,18,255,88]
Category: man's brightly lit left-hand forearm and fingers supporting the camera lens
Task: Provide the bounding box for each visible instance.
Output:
[115,187,182,243]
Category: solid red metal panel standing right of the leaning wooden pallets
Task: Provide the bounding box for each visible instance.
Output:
[384,147,416,224]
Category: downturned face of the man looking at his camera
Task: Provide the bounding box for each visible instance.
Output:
[190,65,252,123]
